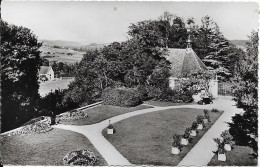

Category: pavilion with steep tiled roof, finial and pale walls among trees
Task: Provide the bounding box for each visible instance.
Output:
[165,38,218,97]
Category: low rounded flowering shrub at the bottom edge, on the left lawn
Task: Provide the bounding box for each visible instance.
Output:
[63,150,97,166]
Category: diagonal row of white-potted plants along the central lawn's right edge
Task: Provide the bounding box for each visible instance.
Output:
[172,110,210,155]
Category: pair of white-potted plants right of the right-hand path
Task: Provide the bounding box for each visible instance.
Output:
[213,130,234,161]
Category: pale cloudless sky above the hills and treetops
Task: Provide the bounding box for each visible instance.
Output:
[1,1,258,44]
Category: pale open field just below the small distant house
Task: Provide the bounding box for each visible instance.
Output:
[39,79,74,97]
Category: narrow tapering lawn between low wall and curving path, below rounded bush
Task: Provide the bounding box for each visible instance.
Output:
[60,104,151,125]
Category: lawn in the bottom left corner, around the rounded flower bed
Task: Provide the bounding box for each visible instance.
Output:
[1,129,107,165]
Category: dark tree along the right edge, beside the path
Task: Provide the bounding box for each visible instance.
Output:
[229,31,259,157]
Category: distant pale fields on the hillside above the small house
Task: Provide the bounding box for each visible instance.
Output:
[40,46,85,63]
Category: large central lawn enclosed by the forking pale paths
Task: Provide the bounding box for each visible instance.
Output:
[102,108,223,166]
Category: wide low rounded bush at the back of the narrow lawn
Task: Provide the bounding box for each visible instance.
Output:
[102,88,142,107]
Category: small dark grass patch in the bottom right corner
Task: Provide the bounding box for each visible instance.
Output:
[208,146,257,166]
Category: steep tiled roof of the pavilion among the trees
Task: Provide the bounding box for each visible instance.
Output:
[166,48,207,78]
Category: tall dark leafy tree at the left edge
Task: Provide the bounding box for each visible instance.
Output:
[0,20,42,132]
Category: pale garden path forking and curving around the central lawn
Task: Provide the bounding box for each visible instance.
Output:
[53,97,241,166]
